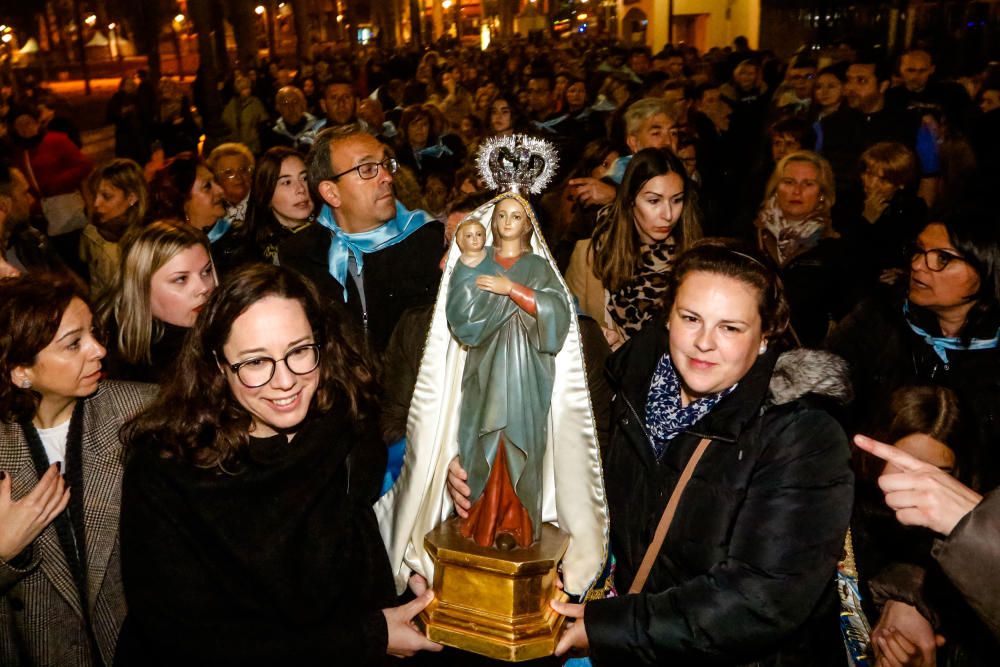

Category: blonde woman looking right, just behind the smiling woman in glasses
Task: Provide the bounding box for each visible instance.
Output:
[98,220,216,382]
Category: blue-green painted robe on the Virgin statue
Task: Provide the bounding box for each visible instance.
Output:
[446,247,572,540]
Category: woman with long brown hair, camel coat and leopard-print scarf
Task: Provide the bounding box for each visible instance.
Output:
[566,148,701,349]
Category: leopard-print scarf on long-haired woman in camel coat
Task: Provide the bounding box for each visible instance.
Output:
[608,236,677,337]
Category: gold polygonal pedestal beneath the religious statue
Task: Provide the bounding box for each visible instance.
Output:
[417,519,569,662]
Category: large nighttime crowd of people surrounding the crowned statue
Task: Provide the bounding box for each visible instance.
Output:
[0,38,1000,667]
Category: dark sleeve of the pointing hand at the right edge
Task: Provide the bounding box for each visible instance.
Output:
[932,491,1000,639]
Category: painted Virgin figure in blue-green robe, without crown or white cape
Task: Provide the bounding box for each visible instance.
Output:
[446,194,571,548]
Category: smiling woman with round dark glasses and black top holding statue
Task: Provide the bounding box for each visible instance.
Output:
[116,264,438,665]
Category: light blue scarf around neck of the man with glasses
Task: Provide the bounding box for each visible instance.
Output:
[316,200,434,303]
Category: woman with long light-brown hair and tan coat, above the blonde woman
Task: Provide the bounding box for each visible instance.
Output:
[80,158,149,301]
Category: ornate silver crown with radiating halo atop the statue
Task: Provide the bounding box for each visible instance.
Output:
[476,134,559,195]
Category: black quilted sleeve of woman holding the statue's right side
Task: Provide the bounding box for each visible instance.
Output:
[584,409,853,664]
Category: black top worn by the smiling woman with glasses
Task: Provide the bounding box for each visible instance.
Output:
[117,410,395,666]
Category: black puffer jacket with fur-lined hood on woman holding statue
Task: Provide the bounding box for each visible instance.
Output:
[584,318,853,665]
